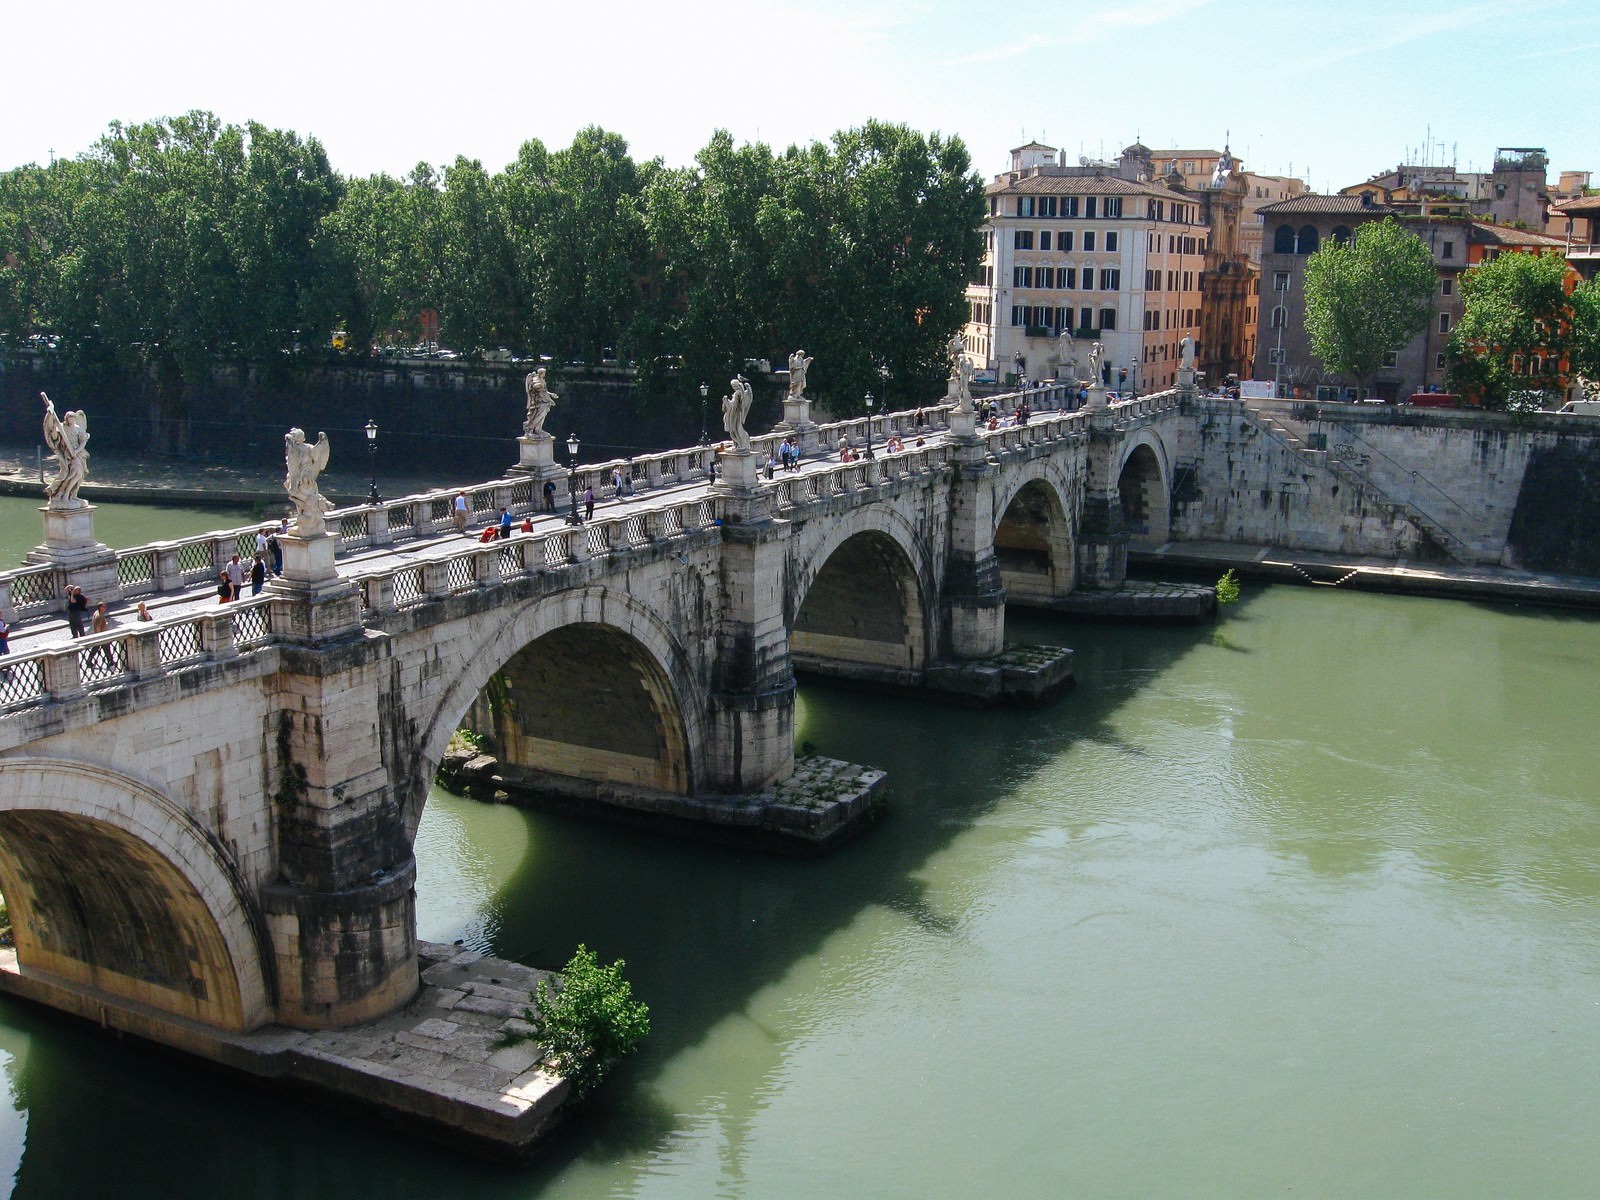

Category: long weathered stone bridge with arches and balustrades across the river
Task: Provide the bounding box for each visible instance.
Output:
[0,390,1192,1048]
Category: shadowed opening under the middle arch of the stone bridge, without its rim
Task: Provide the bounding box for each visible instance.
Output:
[789,528,931,682]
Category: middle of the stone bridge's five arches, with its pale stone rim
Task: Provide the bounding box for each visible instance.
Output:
[784,506,938,680]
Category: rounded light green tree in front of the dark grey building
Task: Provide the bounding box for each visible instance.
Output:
[1306,218,1438,395]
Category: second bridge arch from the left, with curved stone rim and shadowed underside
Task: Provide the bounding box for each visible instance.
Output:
[416,587,706,838]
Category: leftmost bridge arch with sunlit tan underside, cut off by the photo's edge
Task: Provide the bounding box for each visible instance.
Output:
[0,758,272,1030]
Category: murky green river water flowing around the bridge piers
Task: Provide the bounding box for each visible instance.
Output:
[0,506,1600,1200]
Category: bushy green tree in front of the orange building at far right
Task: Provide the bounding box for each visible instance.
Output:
[1450,253,1574,408]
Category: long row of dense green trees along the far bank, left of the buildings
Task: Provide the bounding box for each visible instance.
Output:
[0,112,984,418]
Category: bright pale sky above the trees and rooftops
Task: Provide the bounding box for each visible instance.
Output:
[0,0,1600,190]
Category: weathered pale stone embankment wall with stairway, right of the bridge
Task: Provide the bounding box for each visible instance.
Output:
[1171,398,1600,576]
